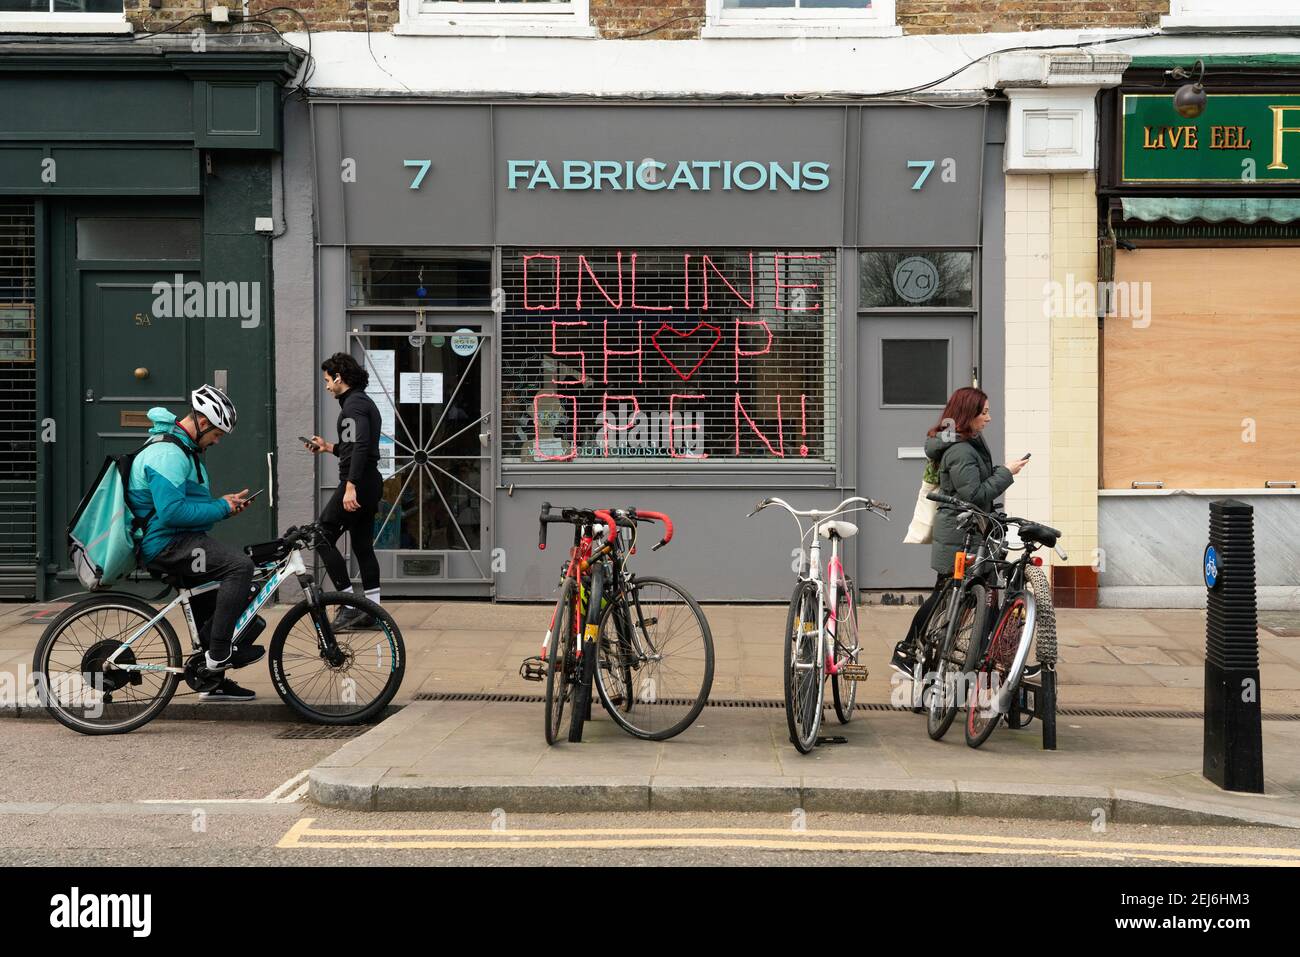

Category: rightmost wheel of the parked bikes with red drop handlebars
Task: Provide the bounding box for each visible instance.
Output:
[595,576,714,741]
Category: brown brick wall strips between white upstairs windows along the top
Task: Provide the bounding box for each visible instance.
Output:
[125,0,1169,40]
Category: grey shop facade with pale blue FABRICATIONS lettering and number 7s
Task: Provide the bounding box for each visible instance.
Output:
[304,98,1005,601]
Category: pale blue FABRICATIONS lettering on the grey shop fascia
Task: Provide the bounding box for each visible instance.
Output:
[506,159,831,192]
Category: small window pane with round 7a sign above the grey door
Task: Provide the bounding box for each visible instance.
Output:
[858,250,975,309]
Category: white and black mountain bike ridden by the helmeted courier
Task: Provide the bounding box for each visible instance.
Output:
[33,523,406,735]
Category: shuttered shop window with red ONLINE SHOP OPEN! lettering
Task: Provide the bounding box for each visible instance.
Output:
[501,248,837,467]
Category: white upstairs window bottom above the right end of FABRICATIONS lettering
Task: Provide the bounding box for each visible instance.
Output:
[702,0,902,38]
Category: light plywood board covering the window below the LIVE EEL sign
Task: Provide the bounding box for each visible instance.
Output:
[1102,246,1300,490]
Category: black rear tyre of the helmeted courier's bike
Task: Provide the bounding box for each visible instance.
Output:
[31,592,185,735]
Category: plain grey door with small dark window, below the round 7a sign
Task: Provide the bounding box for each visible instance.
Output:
[858,316,974,589]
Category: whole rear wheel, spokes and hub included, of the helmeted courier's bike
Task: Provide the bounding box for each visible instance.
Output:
[31,593,183,735]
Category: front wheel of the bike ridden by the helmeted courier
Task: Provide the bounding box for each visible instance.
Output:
[267,592,406,724]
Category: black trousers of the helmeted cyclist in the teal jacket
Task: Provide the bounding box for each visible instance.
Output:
[150,532,254,661]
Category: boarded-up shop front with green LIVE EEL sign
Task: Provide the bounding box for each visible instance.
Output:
[1099,62,1300,609]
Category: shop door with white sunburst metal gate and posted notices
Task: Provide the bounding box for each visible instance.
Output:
[350,313,494,596]
